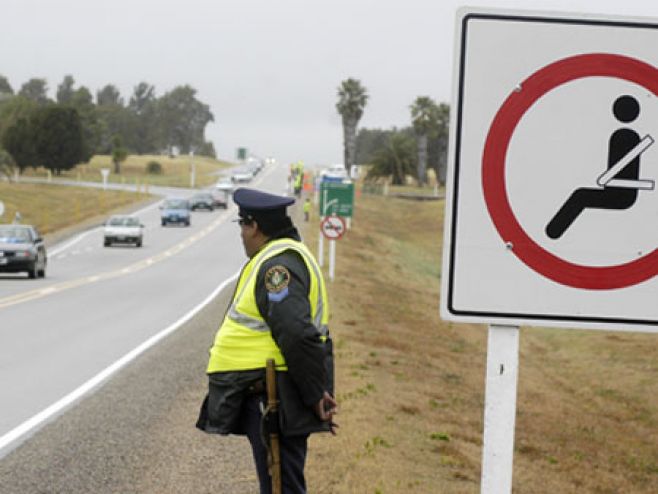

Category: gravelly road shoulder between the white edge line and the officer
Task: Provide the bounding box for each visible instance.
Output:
[0,276,258,494]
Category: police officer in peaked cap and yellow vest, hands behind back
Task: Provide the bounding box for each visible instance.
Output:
[197,188,337,494]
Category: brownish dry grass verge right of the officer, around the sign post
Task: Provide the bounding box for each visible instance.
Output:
[305,192,658,494]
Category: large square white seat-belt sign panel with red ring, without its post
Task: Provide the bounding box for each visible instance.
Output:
[441,10,658,332]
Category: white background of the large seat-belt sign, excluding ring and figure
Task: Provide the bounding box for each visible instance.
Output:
[441,11,658,332]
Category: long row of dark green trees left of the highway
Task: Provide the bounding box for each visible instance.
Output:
[0,75,216,173]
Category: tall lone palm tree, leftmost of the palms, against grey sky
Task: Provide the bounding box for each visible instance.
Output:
[336,78,368,172]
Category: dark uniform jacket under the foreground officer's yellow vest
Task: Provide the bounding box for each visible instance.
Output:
[197,229,334,436]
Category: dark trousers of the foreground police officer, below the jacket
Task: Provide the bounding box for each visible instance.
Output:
[241,394,308,494]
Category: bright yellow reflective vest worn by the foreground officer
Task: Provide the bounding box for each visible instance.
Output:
[207,238,329,374]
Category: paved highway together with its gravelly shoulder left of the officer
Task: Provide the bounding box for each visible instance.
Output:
[0,163,286,493]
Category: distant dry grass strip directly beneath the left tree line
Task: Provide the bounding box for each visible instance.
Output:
[25,155,231,187]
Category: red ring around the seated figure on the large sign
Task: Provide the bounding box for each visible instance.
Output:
[482,53,658,290]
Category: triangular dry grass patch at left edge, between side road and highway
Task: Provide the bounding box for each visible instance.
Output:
[0,182,148,235]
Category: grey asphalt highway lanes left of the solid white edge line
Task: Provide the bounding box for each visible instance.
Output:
[0,190,245,440]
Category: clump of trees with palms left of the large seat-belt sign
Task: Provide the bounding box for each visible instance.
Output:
[336,78,450,185]
